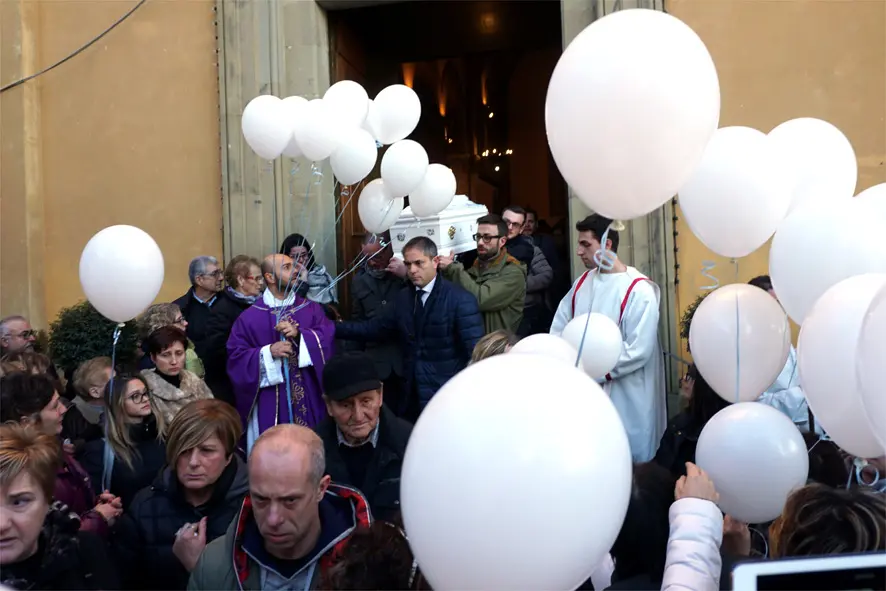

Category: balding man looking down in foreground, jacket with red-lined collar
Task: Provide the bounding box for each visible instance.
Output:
[188,425,372,591]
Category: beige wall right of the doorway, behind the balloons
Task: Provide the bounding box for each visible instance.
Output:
[667,0,886,352]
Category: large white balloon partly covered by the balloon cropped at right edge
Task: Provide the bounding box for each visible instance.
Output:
[797,273,886,458]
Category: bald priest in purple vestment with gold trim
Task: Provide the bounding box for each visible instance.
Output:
[227,254,335,449]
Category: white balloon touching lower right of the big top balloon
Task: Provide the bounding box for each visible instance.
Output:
[680,127,791,258]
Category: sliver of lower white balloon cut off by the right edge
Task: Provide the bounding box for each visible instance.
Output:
[857,288,886,449]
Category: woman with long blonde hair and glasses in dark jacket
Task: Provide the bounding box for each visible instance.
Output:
[79,374,166,509]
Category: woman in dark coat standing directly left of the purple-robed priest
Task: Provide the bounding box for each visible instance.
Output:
[197,255,265,405]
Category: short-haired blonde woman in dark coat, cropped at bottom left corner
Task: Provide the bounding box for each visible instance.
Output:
[0,423,120,589]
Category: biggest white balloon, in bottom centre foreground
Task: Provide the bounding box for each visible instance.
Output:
[401,355,632,591]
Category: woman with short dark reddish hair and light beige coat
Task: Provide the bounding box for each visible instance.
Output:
[141,326,213,434]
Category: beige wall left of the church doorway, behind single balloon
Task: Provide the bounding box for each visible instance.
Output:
[0,0,222,326]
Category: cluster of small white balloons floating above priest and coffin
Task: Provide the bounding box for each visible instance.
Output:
[242,80,456,233]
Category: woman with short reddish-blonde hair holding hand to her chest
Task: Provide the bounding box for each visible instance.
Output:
[119,400,249,589]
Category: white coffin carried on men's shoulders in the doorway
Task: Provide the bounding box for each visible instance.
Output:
[391,195,489,257]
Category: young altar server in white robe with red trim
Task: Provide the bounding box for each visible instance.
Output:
[551,214,667,462]
